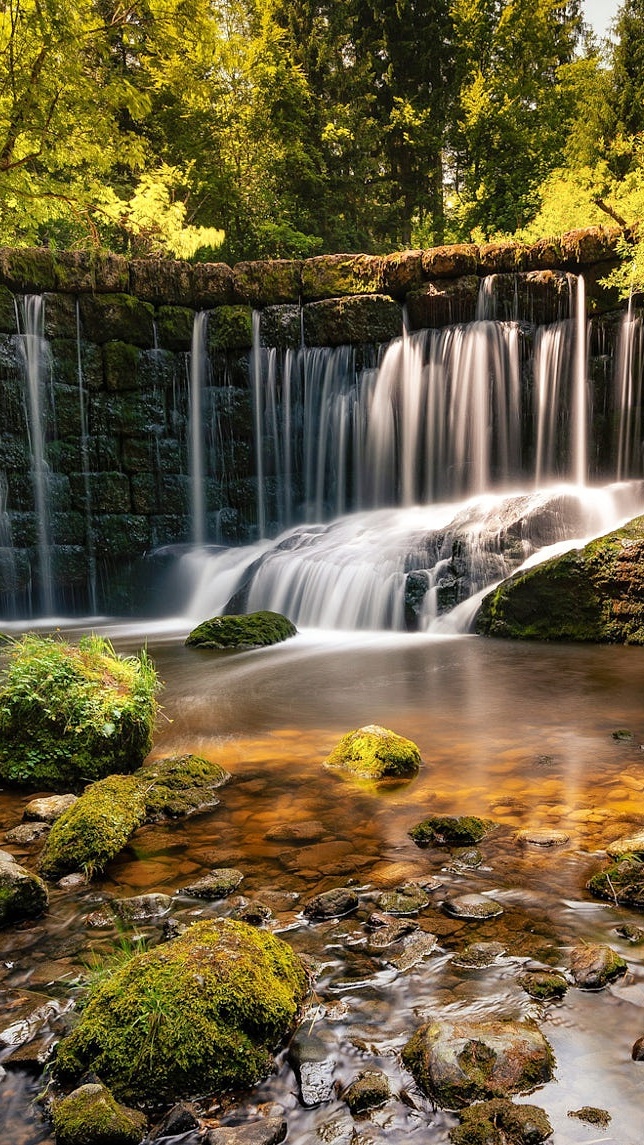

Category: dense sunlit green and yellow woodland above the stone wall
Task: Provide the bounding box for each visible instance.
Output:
[0,0,644,289]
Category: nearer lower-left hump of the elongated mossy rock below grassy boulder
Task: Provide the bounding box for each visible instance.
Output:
[40,775,146,879]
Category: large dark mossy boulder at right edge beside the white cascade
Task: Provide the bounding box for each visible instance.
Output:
[477,516,644,645]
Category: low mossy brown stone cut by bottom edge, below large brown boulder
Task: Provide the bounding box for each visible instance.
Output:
[449,1098,552,1145]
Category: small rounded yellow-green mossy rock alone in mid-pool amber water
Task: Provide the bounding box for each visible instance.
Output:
[324,724,421,780]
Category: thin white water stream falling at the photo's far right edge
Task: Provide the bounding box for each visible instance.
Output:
[615,295,644,481]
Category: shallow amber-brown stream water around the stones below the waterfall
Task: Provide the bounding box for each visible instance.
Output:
[0,633,644,1145]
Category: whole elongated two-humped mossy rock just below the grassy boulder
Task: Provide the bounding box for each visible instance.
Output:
[40,756,230,879]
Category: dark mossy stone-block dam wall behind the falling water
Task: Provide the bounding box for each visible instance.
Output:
[0,228,632,617]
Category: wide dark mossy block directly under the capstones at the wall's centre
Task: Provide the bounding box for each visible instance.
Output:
[304,294,402,346]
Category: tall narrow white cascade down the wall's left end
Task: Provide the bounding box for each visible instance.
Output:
[17,294,54,616]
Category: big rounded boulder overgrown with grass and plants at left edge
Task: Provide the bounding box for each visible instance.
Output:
[0,635,159,792]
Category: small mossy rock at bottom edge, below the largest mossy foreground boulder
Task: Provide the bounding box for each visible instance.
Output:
[52,1082,148,1145]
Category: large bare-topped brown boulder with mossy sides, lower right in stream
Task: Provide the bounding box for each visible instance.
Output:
[402,1019,555,1110]
